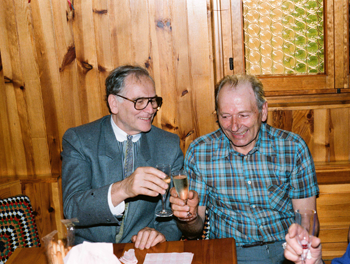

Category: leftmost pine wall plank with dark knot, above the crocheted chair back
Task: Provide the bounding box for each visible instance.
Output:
[0,1,34,175]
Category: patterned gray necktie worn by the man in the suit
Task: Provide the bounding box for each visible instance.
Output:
[115,135,134,243]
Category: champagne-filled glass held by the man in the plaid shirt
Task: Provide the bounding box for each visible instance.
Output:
[171,169,197,221]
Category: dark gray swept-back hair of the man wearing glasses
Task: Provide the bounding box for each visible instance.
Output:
[105,65,154,113]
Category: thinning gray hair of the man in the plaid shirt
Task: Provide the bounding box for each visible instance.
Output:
[215,75,266,112]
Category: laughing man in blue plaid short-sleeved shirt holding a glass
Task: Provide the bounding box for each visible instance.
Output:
[170,75,319,264]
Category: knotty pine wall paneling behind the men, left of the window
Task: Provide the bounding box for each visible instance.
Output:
[0,0,217,175]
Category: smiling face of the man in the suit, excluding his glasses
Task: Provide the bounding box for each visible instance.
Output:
[108,75,157,135]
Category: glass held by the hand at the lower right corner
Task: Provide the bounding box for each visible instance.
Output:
[295,209,317,263]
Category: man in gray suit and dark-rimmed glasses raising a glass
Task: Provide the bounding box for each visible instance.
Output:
[62,65,183,249]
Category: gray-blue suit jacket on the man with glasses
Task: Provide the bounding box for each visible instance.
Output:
[61,116,183,244]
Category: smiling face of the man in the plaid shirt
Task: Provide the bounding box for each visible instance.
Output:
[217,83,267,155]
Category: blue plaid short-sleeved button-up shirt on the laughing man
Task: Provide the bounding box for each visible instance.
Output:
[185,123,319,246]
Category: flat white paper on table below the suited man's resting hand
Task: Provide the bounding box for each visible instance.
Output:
[143,252,193,264]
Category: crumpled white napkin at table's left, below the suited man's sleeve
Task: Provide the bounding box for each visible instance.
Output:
[63,242,121,264]
